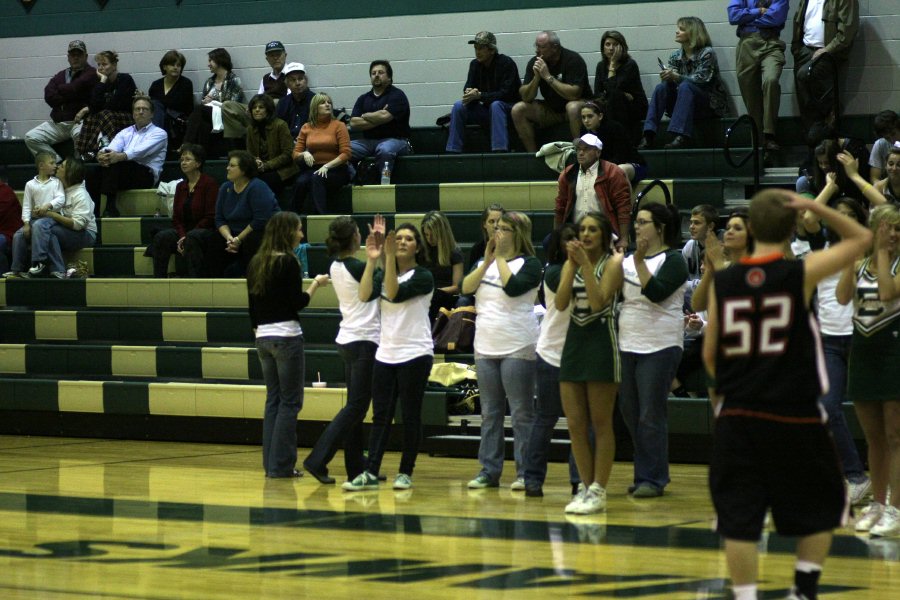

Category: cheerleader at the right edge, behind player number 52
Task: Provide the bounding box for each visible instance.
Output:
[836,204,900,537]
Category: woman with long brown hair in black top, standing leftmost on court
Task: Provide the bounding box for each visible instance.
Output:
[247,212,328,478]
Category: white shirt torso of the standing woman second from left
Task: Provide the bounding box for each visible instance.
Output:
[329,257,381,344]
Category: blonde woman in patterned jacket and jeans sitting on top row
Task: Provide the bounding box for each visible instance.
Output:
[638,17,728,149]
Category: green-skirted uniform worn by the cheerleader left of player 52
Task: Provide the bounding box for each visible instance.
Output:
[559,256,622,383]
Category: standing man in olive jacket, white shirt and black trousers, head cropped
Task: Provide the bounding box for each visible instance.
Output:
[791,0,859,125]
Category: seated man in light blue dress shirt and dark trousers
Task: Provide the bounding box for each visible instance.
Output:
[88,96,169,217]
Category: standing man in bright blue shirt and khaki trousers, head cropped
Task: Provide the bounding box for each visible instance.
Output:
[728,0,788,151]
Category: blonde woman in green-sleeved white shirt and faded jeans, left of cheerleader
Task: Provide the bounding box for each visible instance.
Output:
[463,211,541,491]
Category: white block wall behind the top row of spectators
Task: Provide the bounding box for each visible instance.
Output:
[0,0,900,137]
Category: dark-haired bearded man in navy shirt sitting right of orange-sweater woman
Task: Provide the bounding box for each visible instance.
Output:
[350,60,412,183]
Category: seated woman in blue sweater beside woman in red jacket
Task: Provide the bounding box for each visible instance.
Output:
[214,150,280,277]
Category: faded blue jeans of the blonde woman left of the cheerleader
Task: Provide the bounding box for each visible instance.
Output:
[475,358,534,483]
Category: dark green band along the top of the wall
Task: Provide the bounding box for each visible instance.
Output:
[0,0,648,42]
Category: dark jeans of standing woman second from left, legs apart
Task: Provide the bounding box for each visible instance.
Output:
[304,341,378,481]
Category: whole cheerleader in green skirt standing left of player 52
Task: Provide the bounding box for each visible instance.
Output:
[555,212,623,515]
